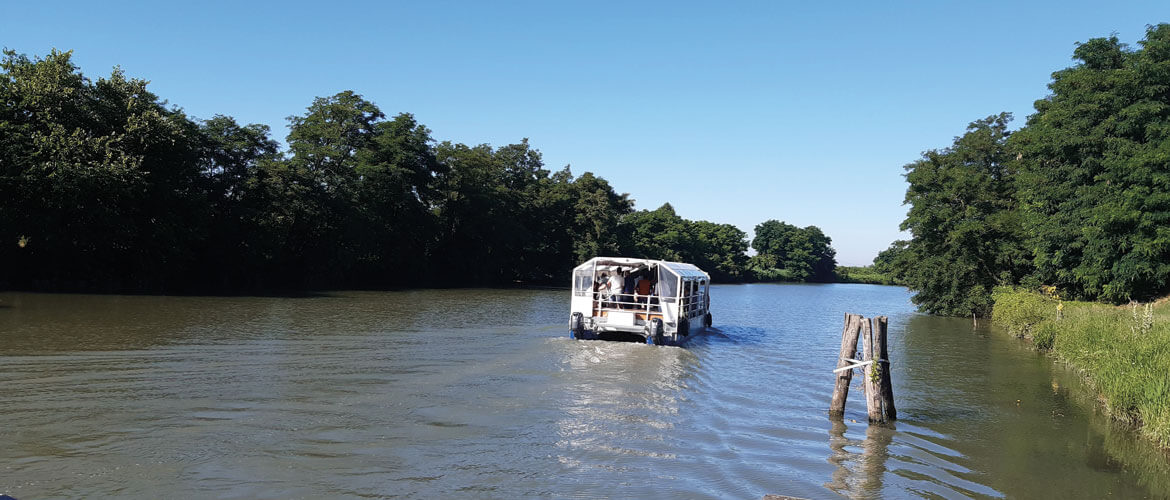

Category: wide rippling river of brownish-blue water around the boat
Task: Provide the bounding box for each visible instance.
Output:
[0,285,1170,500]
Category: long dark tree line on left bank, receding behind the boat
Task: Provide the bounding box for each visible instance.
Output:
[0,50,835,292]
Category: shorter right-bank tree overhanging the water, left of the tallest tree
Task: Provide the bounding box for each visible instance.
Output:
[880,114,1028,316]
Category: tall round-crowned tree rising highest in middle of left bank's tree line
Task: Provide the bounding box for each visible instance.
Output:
[280,90,445,286]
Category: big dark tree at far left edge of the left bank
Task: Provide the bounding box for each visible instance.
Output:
[0,50,208,289]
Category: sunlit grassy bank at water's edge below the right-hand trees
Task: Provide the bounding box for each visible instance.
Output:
[992,289,1170,448]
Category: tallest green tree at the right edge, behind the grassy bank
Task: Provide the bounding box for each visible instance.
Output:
[1012,25,1170,302]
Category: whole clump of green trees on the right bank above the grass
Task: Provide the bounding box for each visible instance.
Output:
[874,23,1170,316]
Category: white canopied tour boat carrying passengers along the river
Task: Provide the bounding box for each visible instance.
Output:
[569,256,711,345]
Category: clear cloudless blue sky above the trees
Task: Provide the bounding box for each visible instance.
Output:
[0,1,1170,265]
